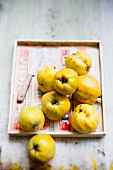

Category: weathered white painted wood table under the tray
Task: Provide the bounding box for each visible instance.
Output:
[0,0,113,170]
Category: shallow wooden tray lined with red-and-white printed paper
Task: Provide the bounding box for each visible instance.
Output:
[8,40,105,137]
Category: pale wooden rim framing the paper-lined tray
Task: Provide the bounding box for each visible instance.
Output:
[8,40,105,137]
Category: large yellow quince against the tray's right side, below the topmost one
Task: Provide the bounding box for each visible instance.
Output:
[74,75,101,104]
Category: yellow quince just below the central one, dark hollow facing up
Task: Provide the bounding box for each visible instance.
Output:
[42,91,71,120]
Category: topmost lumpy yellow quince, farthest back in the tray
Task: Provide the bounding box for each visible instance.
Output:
[65,50,92,76]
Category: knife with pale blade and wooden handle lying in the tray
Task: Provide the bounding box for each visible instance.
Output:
[17,48,46,102]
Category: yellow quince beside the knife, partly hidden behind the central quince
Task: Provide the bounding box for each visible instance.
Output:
[37,66,59,93]
